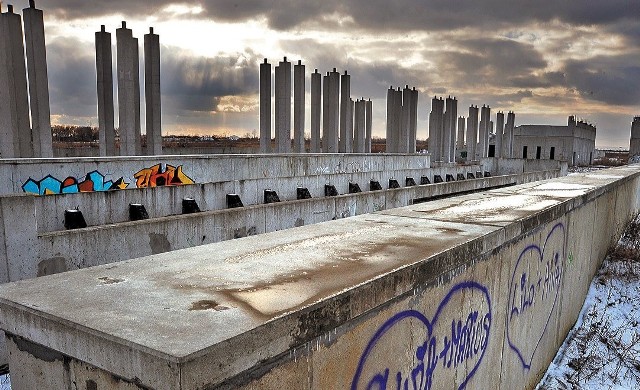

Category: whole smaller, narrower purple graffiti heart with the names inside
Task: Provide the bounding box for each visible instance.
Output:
[506,223,565,370]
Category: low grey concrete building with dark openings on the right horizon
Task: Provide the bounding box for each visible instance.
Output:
[512,116,596,165]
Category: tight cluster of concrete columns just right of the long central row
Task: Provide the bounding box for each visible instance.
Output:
[385,85,418,153]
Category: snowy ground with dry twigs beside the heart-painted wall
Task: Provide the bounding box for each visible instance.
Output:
[537,217,640,390]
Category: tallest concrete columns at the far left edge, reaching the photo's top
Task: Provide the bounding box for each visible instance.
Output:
[0,0,53,158]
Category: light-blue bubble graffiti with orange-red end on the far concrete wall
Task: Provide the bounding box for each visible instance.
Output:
[22,171,129,195]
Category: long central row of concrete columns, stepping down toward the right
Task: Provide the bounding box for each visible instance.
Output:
[260,57,372,153]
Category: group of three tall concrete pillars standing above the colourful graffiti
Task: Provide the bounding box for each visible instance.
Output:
[95,21,162,156]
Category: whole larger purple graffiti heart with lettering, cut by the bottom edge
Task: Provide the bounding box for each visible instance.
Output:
[351,281,492,390]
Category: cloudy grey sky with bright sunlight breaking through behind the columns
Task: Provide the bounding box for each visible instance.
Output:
[12,0,640,147]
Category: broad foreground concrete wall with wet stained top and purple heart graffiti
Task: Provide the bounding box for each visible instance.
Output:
[0,166,640,390]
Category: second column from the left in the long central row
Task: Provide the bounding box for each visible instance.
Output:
[275,57,291,153]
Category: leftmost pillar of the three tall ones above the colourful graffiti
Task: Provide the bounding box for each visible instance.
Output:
[96,26,116,156]
